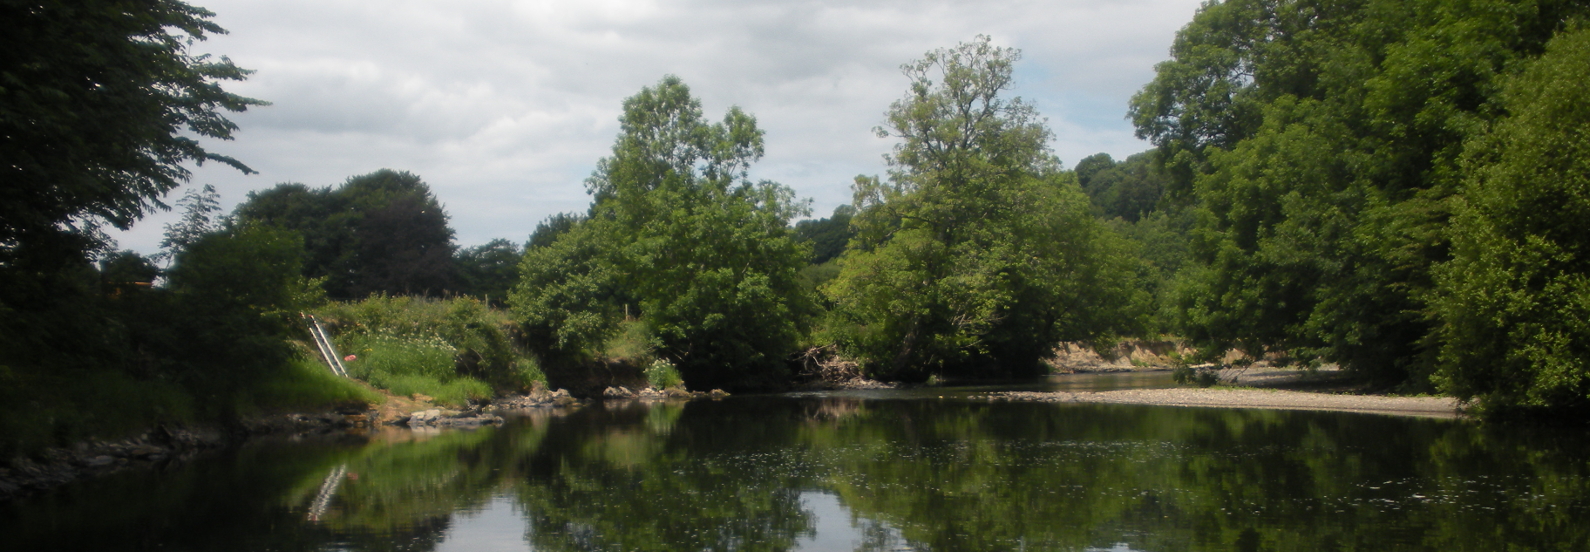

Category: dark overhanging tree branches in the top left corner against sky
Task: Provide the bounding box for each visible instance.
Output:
[0,0,266,267]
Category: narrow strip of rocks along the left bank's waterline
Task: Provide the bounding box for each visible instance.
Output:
[0,387,728,501]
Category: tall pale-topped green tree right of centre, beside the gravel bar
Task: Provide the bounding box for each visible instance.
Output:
[824,37,1127,379]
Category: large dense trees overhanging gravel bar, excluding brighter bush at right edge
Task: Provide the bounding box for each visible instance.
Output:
[1132,0,1584,397]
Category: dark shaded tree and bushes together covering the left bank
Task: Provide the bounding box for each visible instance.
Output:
[0,0,381,458]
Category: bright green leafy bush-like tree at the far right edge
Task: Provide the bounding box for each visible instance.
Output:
[1433,29,1590,417]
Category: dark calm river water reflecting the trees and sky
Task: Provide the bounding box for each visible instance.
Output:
[0,375,1590,552]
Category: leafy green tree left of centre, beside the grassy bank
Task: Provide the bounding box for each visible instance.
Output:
[514,76,809,387]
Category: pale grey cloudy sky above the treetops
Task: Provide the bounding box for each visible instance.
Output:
[114,0,1199,253]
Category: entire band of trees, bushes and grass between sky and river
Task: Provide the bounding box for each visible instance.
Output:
[0,0,1590,457]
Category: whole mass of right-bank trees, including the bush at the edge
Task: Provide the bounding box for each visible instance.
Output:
[1119,0,1590,415]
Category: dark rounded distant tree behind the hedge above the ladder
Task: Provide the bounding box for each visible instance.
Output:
[234,169,455,299]
